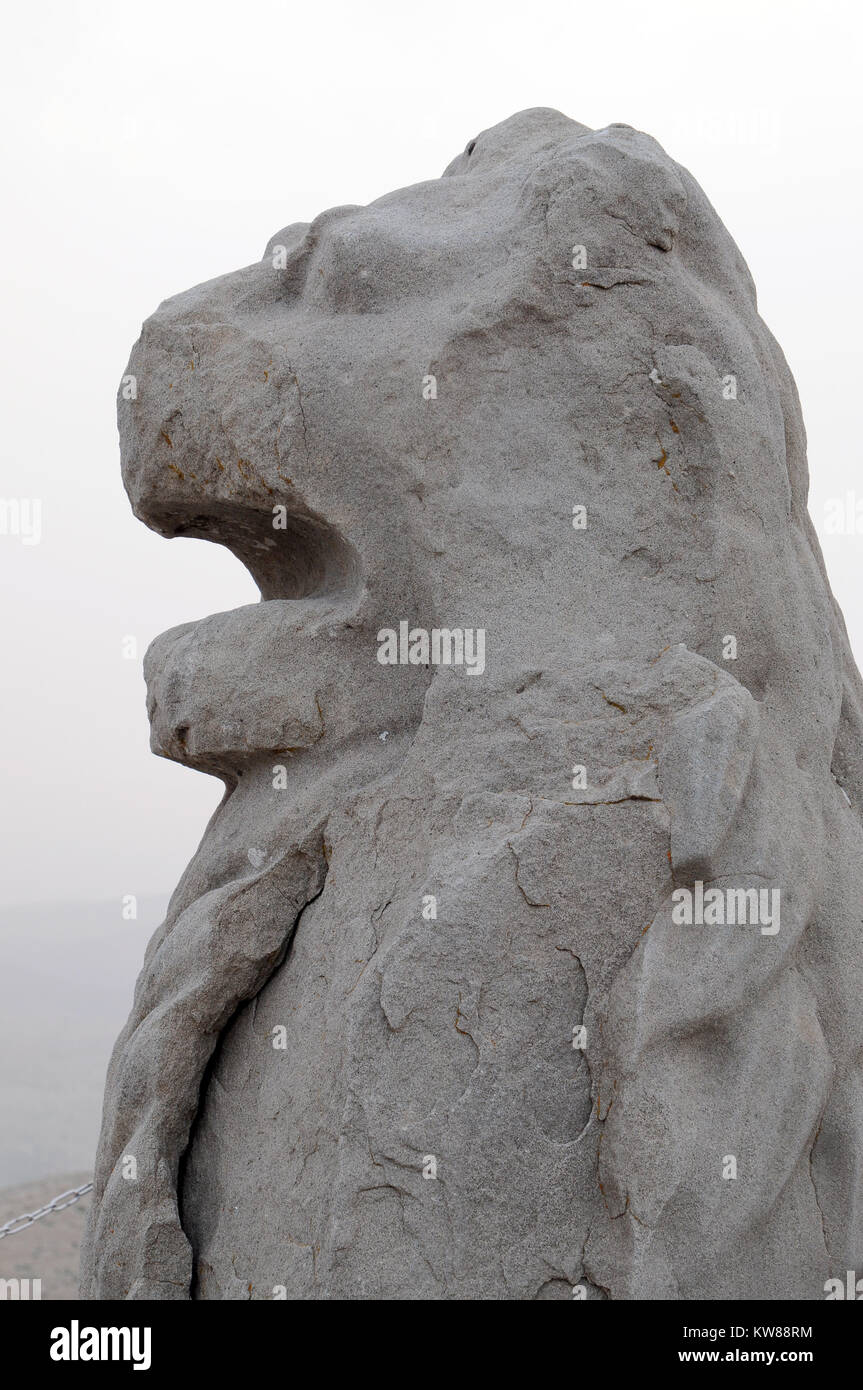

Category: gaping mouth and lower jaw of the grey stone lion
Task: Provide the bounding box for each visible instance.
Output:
[145,499,364,781]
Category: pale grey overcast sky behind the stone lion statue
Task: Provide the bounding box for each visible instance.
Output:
[0,0,863,904]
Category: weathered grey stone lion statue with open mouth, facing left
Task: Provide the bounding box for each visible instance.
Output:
[83,110,863,1300]
